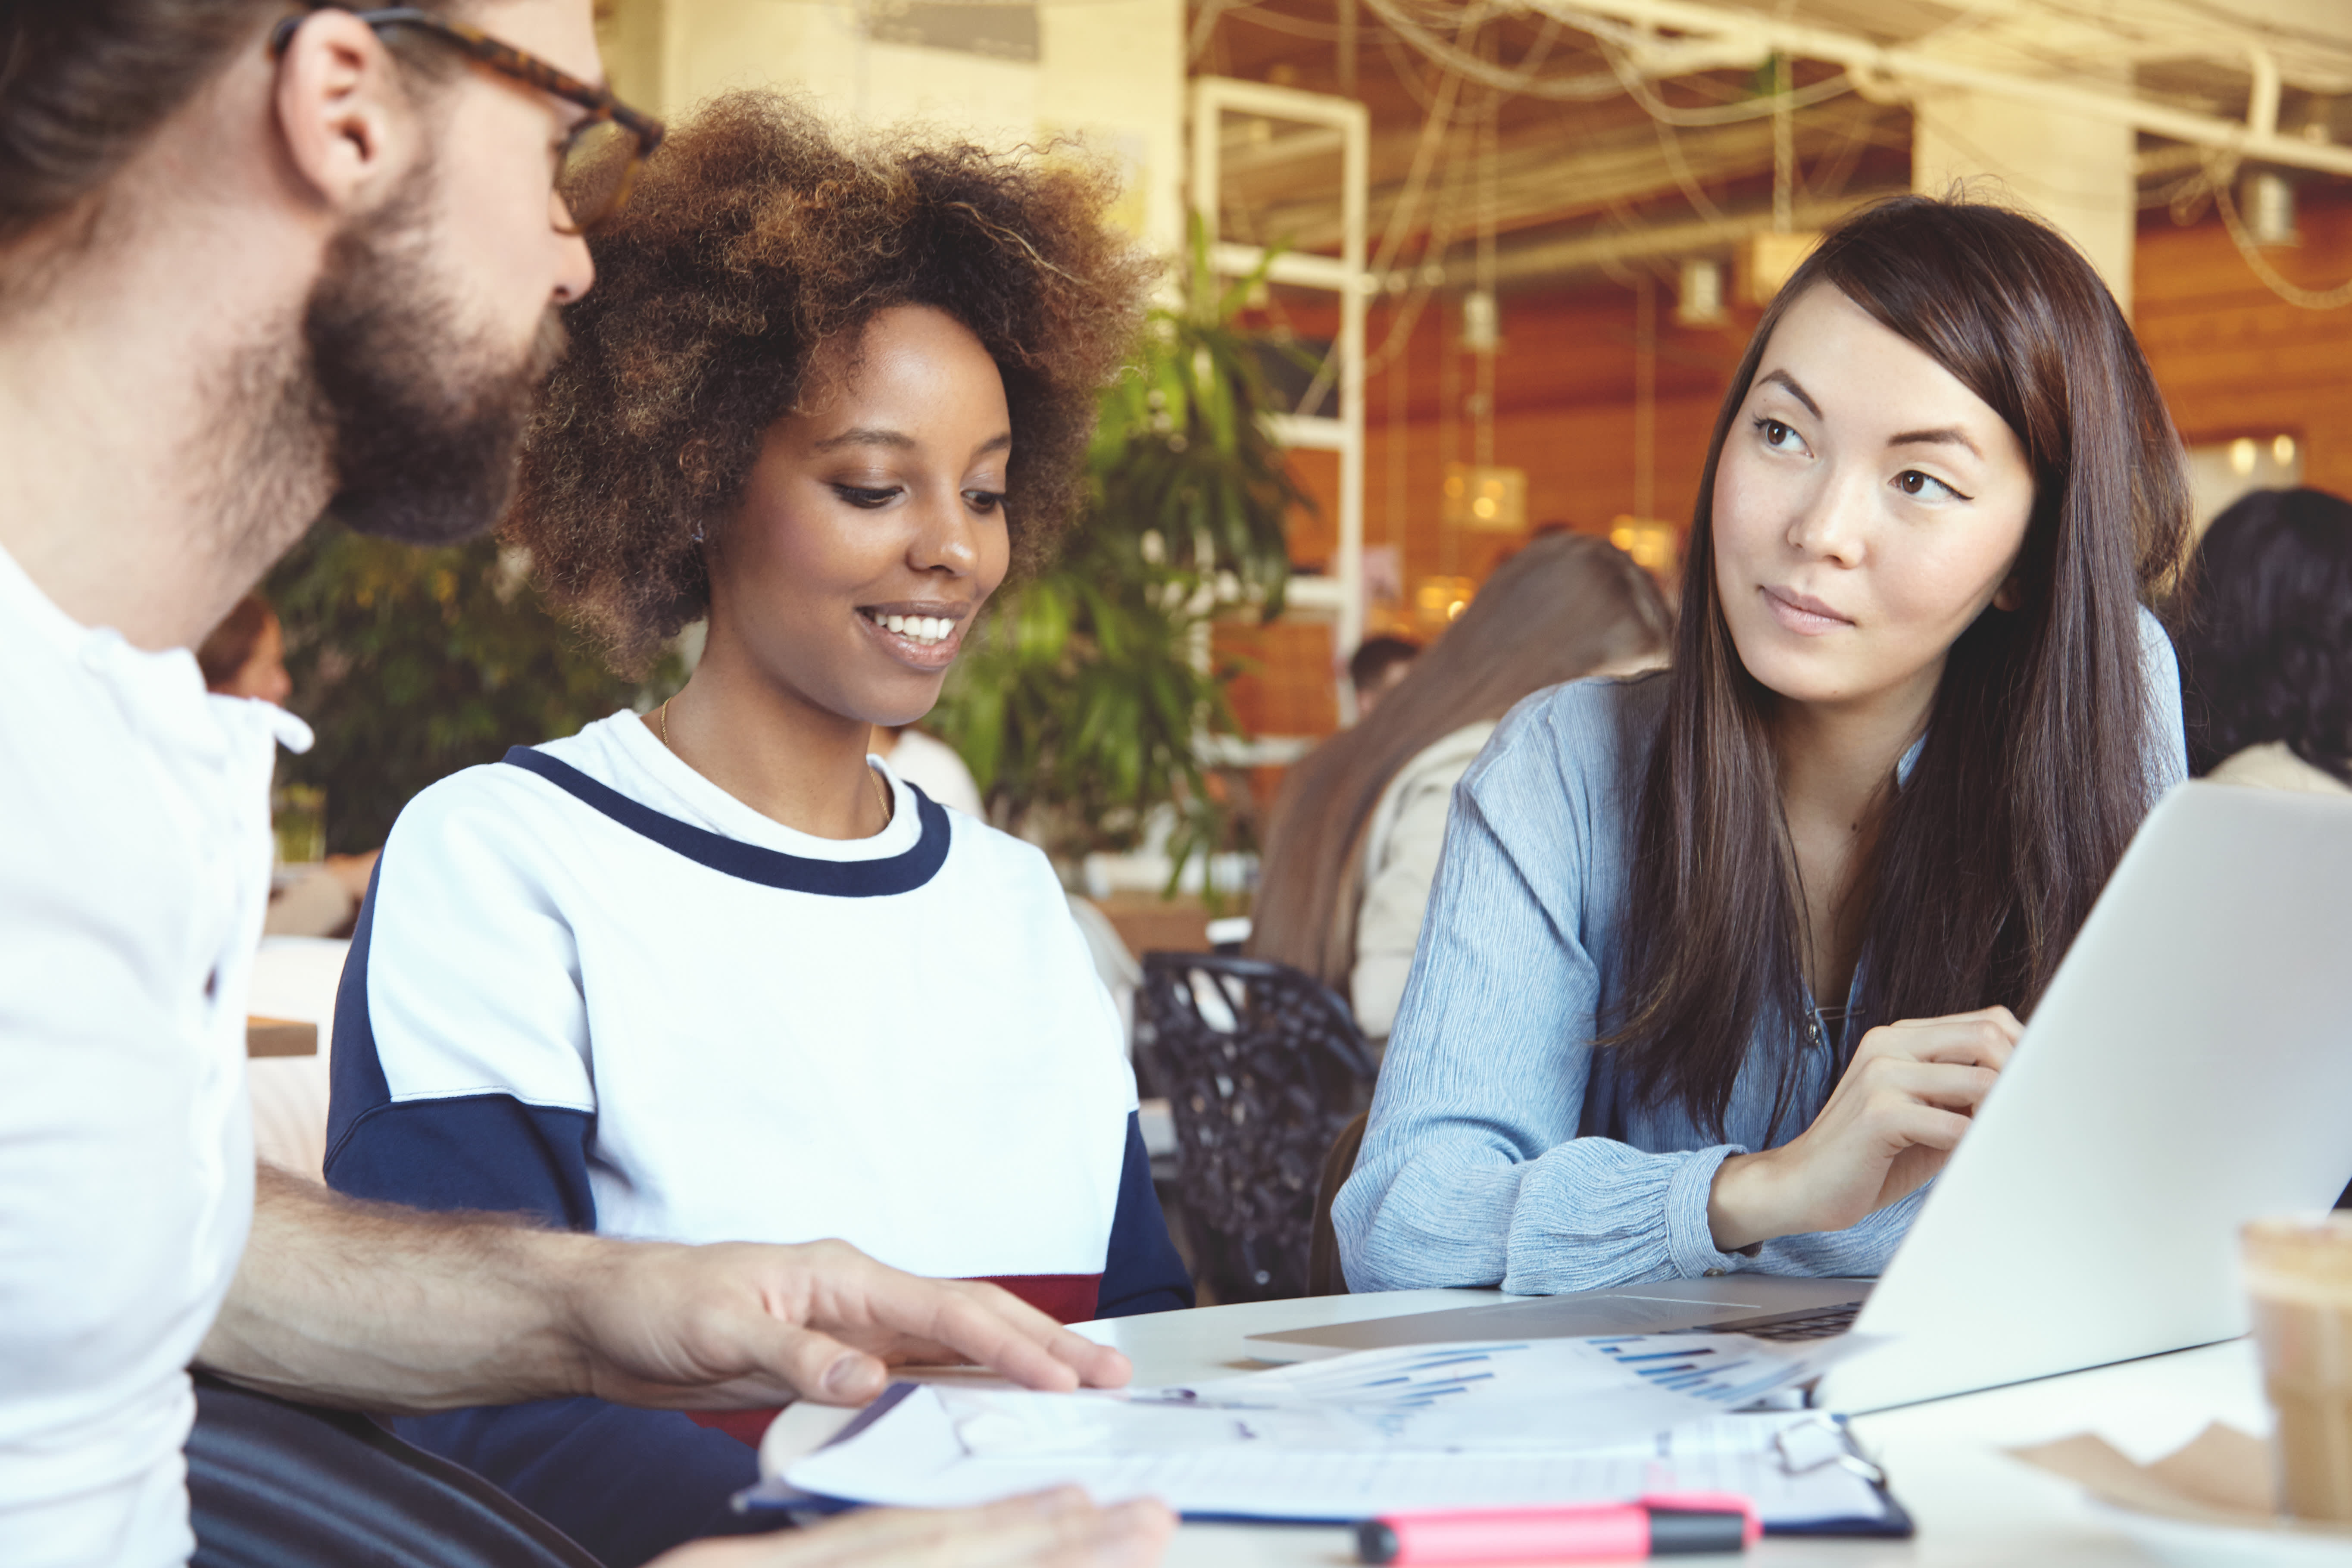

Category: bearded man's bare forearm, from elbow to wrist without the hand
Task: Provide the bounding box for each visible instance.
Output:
[197,1166,602,1413]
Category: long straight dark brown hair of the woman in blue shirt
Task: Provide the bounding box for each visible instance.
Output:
[1602,195,2190,1135]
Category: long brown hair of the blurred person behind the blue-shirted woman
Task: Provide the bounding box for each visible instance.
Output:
[1249,534,1672,992]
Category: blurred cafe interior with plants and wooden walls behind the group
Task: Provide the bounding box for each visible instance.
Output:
[271,0,2352,952]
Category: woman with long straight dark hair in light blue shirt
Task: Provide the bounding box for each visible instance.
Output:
[1334,197,2187,1293]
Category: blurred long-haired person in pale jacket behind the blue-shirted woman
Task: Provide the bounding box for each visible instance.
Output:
[1249,534,1672,1041]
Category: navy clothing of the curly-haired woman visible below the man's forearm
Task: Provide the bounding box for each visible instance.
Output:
[393,1399,776,1568]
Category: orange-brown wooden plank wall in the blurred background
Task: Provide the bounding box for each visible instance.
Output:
[1221,183,2352,752]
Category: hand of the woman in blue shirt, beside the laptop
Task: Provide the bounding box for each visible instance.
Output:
[1708,1006,2025,1253]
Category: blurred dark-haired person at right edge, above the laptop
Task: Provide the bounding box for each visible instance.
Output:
[2180,489,2352,795]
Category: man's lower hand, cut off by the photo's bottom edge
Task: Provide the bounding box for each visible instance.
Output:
[652,1488,1176,1568]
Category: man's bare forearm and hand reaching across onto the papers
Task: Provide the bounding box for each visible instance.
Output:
[197,1166,1129,1413]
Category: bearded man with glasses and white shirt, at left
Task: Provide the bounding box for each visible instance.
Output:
[0,0,1169,1568]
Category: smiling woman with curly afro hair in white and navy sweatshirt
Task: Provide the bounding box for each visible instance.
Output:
[327,94,1193,1563]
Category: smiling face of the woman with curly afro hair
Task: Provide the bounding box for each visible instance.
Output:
[710,306,1012,724]
